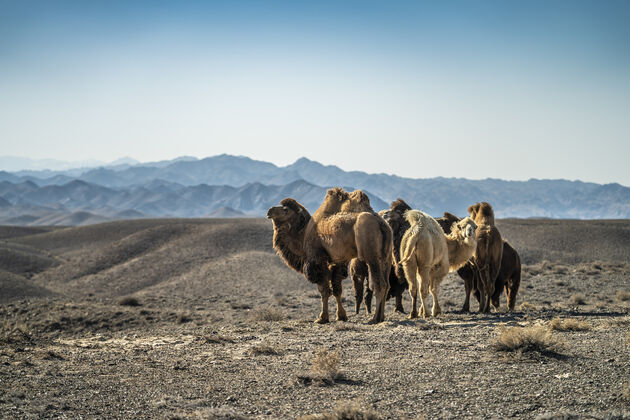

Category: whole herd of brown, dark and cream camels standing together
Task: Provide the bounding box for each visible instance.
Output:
[267,188,521,324]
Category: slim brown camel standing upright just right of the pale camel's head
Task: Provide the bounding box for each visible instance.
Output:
[462,202,503,312]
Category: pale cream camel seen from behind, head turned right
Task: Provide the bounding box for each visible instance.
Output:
[400,210,477,318]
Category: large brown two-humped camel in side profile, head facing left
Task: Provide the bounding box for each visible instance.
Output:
[267,188,393,324]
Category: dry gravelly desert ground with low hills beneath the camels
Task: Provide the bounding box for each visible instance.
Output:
[0,219,630,419]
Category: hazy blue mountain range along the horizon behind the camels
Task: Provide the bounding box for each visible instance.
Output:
[0,155,630,225]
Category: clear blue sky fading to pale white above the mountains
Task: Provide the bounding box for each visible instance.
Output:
[0,0,630,186]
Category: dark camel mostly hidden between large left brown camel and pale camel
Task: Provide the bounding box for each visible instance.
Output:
[350,198,411,314]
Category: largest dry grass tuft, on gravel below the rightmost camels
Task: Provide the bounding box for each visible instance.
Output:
[494,325,564,354]
